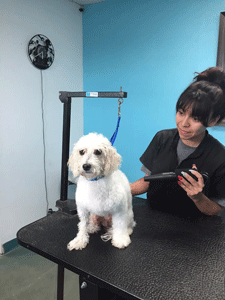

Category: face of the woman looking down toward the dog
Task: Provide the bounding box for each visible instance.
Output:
[176,107,206,147]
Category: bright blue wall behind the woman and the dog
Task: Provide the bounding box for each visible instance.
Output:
[83,0,225,182]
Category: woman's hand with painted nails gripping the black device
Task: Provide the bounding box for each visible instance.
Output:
[178,165,204,202]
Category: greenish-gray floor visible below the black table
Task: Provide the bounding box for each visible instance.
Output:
[0,246,79,300]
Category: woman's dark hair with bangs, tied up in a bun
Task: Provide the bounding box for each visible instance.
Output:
[176,67,225,127]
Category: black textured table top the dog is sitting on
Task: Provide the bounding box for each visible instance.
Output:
[17,198,225,300]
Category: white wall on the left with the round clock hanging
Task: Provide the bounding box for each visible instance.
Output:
[0,0,83,244]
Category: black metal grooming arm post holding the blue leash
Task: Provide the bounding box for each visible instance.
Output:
[56,87,127,214]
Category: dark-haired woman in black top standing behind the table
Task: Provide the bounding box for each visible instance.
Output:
[131,67,225,217]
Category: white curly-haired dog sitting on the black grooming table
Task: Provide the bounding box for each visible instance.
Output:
[67,133,136,250]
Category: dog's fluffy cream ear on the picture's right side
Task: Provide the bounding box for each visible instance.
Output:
[104,146,122,176]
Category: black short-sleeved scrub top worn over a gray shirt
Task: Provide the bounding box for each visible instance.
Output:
[140,129,225,217]
